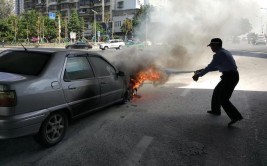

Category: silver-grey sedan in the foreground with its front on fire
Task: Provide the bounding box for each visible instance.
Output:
[0,48,127,146]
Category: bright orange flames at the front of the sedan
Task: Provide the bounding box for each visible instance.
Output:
[131,67,161,89]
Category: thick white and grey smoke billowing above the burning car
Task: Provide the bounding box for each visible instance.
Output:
[109,0,260,83]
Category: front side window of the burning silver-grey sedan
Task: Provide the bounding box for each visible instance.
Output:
[89,57,116,77]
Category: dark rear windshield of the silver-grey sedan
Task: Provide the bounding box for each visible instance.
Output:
[0,51,52,76]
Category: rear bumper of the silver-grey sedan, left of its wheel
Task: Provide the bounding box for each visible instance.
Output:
[0,110,48,139]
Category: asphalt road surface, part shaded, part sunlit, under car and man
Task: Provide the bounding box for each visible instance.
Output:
[0,45,267,166]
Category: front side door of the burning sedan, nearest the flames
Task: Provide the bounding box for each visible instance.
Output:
[89,56,125,105]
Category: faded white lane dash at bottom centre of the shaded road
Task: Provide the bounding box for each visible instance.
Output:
[124,136,153,166]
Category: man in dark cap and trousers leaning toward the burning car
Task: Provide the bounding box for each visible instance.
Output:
[193,38,243,127]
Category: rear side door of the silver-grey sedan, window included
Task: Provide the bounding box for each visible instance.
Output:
[62,55,100,116]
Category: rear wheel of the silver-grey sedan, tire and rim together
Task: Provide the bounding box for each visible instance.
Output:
[35,111,68,147]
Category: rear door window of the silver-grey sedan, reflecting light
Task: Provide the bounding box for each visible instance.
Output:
[63,57,94,81]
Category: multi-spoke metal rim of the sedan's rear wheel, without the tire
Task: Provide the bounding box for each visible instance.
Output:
[45,114,65,142]
